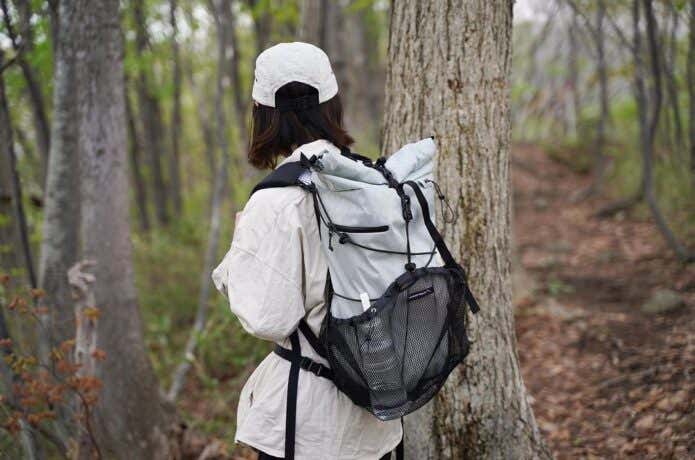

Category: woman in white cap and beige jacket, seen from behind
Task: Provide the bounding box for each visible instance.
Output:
[213,42,402,460]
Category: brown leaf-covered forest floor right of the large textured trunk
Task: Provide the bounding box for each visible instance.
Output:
[512,146,695,459]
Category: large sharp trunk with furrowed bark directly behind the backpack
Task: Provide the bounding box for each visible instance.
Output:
[384,0,550,460]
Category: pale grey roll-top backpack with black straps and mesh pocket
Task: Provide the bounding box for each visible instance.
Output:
[249,138,479,458]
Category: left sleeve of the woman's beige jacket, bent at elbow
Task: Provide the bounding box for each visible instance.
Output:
[212,191,305,341]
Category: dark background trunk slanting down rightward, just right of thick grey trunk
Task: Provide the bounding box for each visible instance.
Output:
[132,0,169,225]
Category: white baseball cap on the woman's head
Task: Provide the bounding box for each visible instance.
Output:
[251,42,338,107]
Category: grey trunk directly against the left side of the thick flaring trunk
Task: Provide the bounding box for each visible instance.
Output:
[39,1,80,359]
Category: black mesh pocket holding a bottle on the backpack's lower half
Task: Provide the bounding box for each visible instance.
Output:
[323,267,468,420]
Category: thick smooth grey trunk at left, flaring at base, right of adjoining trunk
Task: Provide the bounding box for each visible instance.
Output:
[71,0,176,459]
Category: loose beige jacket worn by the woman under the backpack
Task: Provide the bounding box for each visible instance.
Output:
[212,140,402,460]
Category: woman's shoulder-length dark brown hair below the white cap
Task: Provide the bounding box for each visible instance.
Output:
[248,82,354,169]
